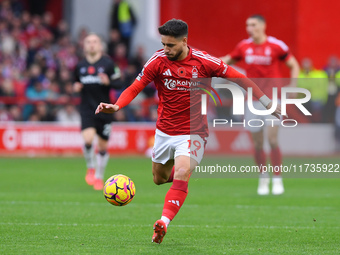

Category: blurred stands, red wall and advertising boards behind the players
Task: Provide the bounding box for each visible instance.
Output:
[0,0,340,156]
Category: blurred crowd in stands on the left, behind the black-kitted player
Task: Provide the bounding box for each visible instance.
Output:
[0,0,157,123]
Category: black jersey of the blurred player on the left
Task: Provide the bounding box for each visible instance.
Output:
[75,56,120,117]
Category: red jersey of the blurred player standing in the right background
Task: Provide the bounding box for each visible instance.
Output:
[230,36,291,98]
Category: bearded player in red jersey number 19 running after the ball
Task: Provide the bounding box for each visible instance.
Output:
[96,19,281,243]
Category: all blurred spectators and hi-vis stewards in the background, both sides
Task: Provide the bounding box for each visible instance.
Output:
[0,0,340,131]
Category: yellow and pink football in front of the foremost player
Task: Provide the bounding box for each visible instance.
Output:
[103,174,136,206]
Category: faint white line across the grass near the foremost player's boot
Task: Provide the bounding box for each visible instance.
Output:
[0,222,340,229]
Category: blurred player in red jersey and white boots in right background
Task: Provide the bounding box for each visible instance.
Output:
[221,15,299,195]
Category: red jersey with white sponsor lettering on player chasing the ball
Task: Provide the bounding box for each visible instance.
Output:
[136,48,228,136]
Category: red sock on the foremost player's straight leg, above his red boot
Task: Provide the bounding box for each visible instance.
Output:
[162,179,188,220]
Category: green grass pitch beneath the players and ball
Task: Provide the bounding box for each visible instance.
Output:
[0,157,340,255]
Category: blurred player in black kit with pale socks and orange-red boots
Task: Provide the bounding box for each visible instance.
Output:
[74,34,121,190]
